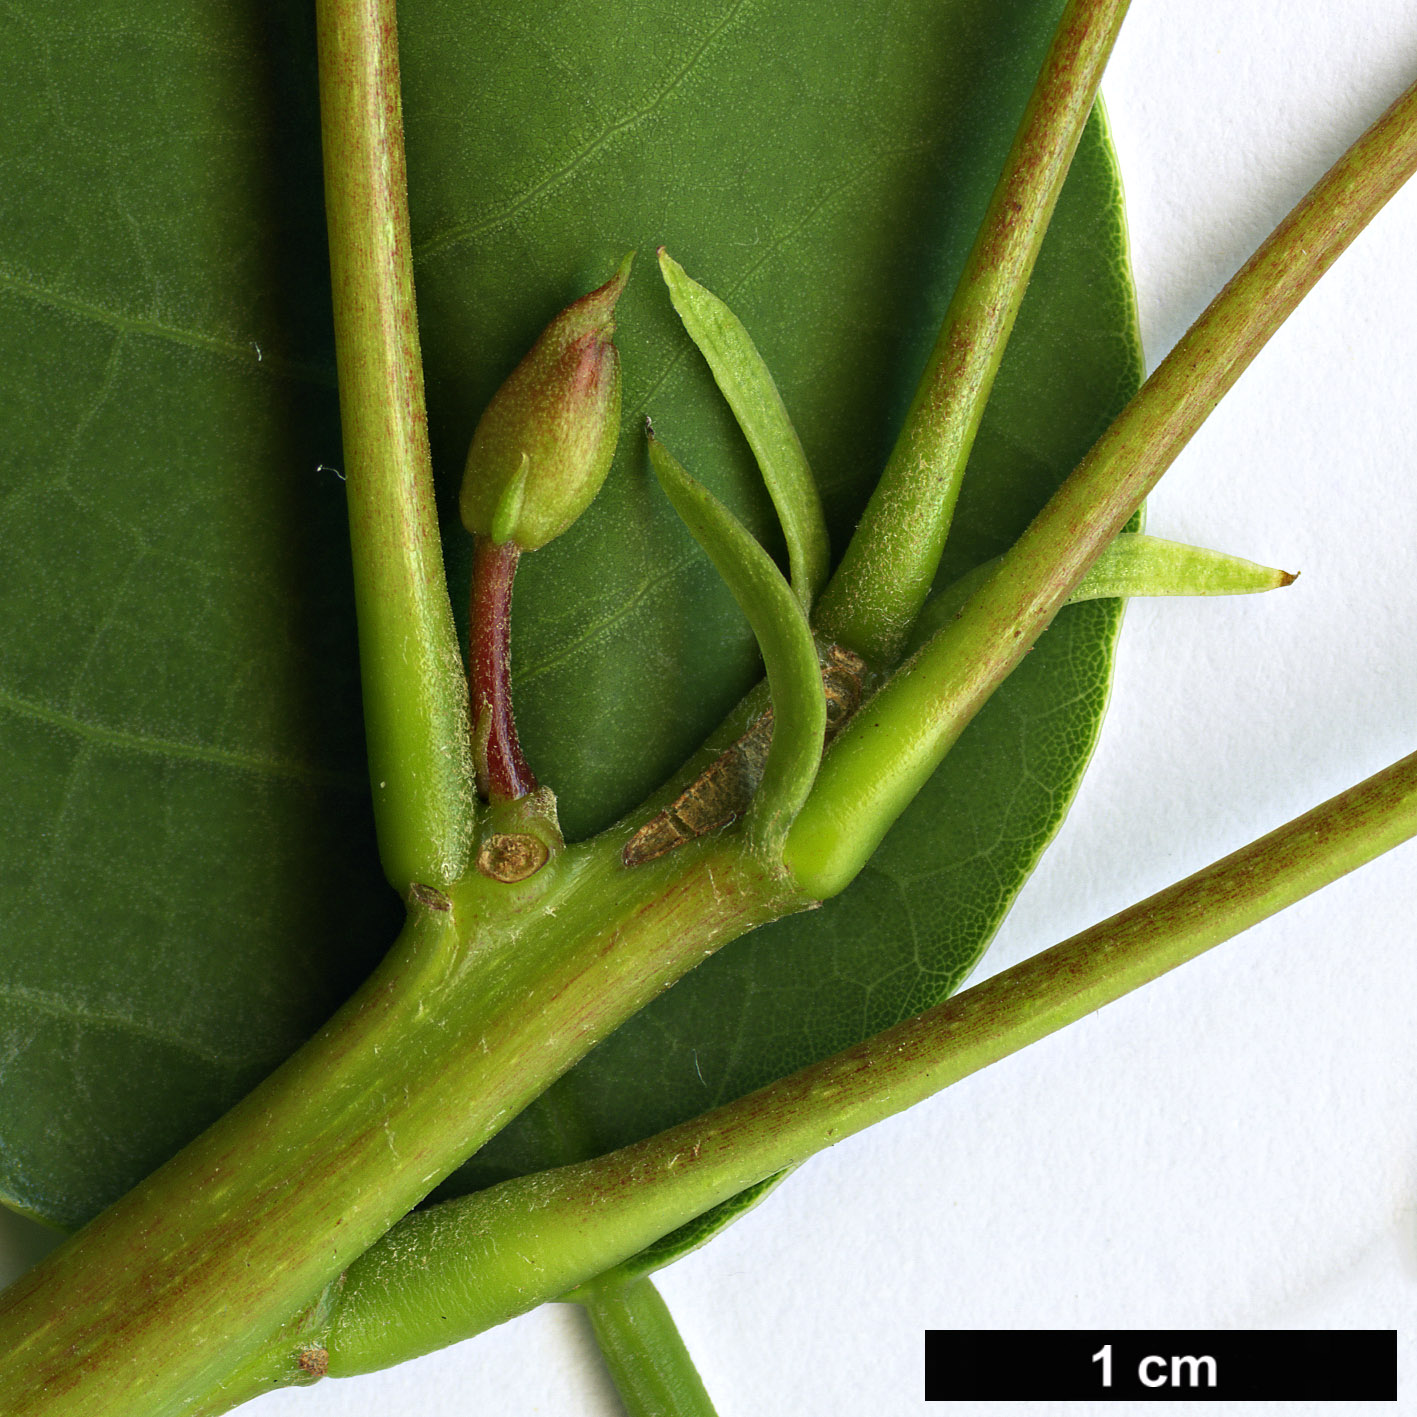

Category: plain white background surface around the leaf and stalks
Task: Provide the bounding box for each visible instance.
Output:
[0,0,1417,1417]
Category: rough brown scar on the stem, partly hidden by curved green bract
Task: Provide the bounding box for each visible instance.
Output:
[621,645,866,866]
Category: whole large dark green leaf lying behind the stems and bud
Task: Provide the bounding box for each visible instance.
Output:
[0,0,1138,1252]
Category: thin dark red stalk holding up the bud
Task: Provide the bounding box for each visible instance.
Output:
[468,536,537,802]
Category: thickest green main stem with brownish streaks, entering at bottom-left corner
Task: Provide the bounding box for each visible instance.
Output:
[0,836,792,1417]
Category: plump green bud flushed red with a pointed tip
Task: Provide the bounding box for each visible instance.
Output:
[462,255,632,551]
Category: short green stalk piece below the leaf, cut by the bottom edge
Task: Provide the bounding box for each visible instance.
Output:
[572,1280,716,1417]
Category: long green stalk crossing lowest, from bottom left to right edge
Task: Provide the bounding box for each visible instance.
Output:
[214,754,1417,1388]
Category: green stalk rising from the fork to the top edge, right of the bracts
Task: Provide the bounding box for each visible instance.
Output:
[815,0,1128,669]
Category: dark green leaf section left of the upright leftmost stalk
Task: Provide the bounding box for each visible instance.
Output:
[0,0,398,1226]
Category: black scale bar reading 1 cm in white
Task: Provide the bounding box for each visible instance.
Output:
[925,1329,1397,1403]
